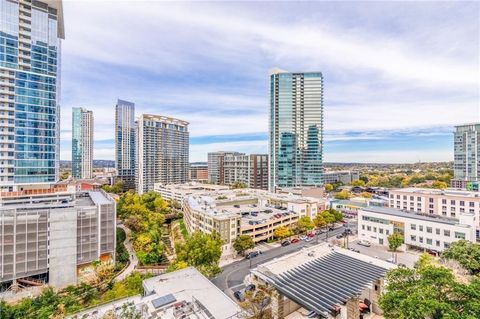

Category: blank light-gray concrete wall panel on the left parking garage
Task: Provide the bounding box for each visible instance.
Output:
[49,208,77,288]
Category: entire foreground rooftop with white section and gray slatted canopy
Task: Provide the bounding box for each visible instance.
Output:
[252,243,395,315]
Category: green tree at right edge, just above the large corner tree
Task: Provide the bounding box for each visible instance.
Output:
[442,240,480,275]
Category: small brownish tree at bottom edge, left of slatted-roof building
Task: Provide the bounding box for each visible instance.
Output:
[240,286,272,319]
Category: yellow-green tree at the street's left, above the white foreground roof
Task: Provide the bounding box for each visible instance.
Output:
[175,231,223,277]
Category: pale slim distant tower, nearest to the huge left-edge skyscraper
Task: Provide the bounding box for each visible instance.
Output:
[72,107,93,179]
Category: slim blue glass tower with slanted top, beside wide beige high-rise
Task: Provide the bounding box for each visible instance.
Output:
[115,99,136,190]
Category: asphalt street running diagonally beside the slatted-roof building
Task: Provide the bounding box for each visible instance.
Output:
[212,226,344,296]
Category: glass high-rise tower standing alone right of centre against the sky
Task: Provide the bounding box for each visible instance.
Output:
[269,69,323,191]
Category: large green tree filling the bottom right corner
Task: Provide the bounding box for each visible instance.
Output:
[379,258,480,319]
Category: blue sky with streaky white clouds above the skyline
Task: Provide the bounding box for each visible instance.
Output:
[61,0,480,163]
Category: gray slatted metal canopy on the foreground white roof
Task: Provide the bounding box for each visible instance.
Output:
[270,251,387,316]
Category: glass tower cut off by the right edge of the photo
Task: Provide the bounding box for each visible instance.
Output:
[452,123,480,191]
